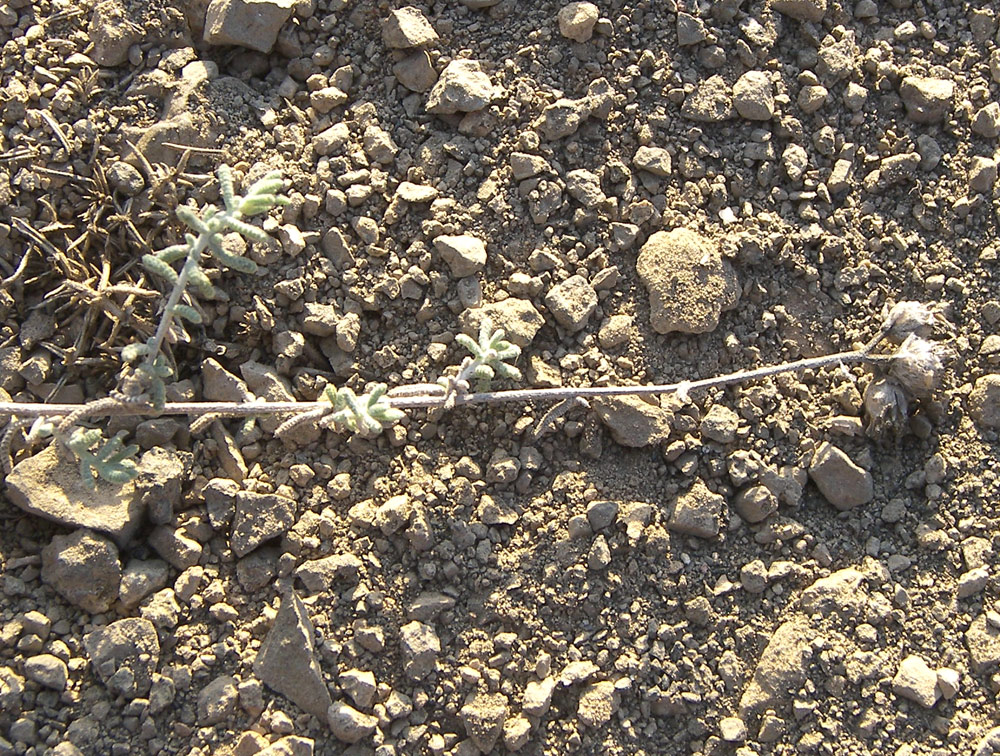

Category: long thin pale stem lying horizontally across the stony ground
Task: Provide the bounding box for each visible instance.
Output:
[0,349,876,417]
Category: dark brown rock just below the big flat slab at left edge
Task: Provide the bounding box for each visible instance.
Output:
[42,529,121,614]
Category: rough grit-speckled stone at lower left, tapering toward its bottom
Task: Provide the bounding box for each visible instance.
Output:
[83,617,160,699]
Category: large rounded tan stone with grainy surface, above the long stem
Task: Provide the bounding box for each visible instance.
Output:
[636,228,741,333]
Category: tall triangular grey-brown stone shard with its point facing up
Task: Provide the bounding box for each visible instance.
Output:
[253,592,332,721]
